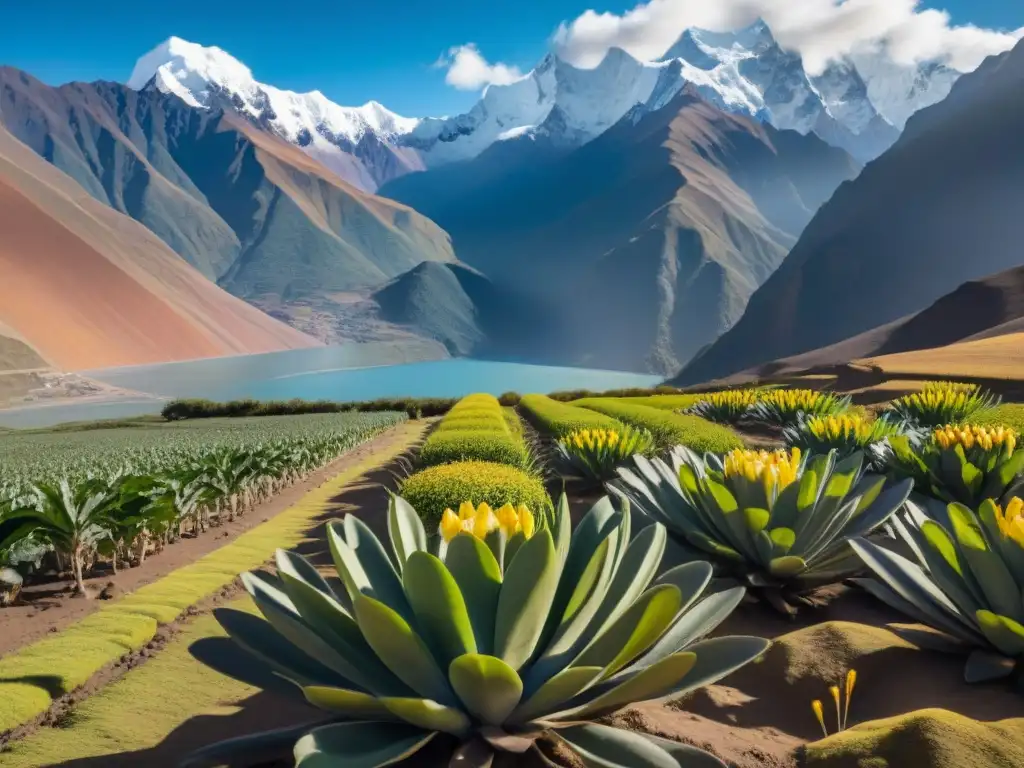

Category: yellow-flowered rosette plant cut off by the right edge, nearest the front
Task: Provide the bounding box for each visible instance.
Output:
[852,497,1024,690]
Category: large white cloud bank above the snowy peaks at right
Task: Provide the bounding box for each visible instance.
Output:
[555,0,1024,73]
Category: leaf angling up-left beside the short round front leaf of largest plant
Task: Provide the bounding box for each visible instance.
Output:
[354,595,455,703]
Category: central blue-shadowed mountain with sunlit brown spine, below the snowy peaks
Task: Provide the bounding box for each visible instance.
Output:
[381,87,858,371]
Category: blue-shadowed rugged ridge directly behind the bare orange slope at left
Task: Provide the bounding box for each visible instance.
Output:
[0,69,455,339]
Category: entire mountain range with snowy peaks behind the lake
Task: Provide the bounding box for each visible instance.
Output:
[0,22,1019,382]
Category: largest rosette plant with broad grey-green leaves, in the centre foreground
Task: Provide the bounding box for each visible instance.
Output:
[184,498,769,768]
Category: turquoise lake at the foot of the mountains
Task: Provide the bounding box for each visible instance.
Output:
[0,347,662,428]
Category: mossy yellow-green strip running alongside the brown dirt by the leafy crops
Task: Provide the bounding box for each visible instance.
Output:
[0,422,424,741]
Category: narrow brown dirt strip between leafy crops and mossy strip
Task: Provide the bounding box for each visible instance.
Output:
[0,423,415,655]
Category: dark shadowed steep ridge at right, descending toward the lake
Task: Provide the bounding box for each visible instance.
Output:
[677,37,1024,384]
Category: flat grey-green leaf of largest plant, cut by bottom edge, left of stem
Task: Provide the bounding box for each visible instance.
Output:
[295,722,436,768]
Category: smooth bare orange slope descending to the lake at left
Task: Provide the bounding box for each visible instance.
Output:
[0,121,316,370]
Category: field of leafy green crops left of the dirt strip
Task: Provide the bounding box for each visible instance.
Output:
[0,413,407,602]
